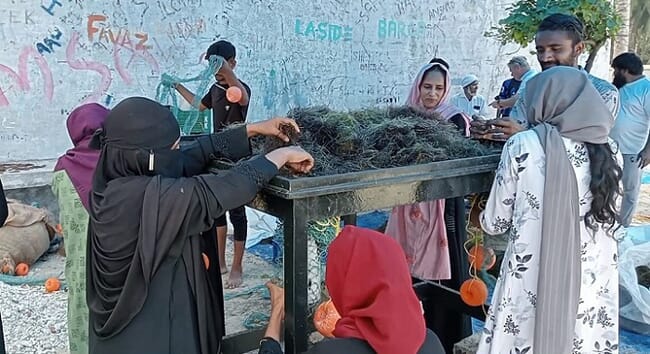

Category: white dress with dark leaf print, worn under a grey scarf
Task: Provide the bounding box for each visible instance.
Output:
[477,130,618,354]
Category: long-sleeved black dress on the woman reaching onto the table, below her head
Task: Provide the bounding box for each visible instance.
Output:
[88,127,278,354]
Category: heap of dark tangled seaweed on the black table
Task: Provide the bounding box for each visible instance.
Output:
[253,107,494,175]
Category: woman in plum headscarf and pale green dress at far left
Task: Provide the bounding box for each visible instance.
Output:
[52,103,110,354]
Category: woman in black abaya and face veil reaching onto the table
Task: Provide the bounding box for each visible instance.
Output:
[87,97,313,354]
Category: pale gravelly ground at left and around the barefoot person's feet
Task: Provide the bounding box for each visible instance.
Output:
[0,241,277,354]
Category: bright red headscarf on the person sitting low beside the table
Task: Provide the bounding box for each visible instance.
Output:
[325,226,426,354]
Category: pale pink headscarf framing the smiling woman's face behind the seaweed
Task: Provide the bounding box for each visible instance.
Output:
[406,63,472,136]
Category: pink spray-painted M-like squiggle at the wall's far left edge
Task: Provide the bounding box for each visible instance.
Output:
[0,46,54,107]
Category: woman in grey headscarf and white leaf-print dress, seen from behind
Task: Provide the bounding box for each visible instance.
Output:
[478,67,621,354]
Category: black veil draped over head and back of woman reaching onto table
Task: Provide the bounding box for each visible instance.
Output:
[88,97,205,338]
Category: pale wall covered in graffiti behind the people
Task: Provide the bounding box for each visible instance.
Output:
[0,0,608,162]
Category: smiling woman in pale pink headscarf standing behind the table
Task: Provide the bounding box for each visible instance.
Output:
[385,59,472,352]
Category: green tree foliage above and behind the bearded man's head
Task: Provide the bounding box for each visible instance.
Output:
[485,0,622,67]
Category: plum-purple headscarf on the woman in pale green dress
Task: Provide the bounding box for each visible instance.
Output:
[54,103,110,210]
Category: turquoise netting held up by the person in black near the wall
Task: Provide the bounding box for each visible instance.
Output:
[156,55,225,135]
